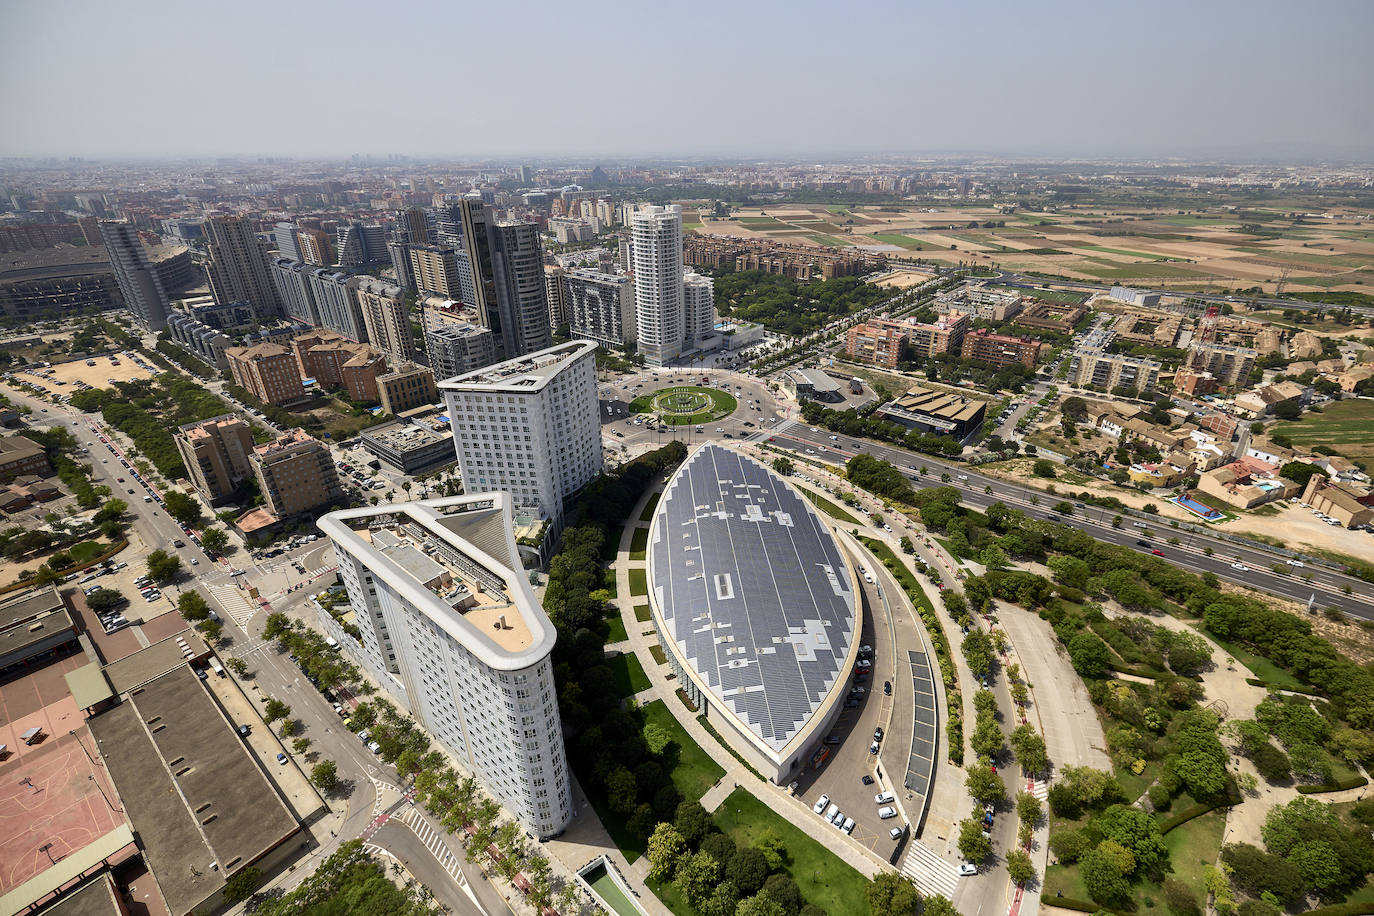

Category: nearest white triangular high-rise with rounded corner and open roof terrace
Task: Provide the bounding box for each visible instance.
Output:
[319,493,573,839]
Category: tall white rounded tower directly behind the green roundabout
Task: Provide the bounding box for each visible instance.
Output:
[631,203,687,365]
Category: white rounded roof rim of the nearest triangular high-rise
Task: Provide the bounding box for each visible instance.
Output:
[316,490,558,672]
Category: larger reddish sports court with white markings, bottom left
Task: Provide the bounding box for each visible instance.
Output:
[0,725,125,894]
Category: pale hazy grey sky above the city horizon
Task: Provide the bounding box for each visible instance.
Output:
[0,0,1374,159]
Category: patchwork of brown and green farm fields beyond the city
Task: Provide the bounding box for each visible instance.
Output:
[699,201,1374,293]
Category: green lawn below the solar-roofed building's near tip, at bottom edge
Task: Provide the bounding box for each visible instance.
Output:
[716,788,871,916]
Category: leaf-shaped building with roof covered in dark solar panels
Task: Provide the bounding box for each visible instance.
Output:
[649,445,863,786]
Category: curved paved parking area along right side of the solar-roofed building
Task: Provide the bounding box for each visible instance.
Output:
[797,570,911,860]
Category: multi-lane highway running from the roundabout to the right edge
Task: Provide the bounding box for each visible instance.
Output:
[768,424,1374,619]
